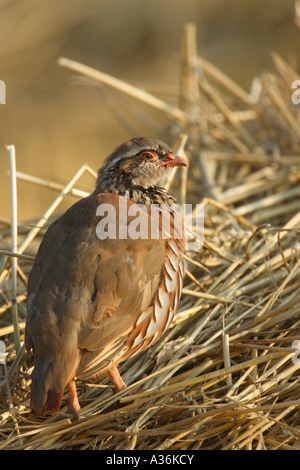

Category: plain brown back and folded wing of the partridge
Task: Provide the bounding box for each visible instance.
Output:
[26,194,165,407]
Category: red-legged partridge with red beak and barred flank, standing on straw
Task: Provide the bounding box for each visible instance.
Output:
[25,138,186,416]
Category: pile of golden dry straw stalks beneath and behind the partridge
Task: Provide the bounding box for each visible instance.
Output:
[0,25,300,450]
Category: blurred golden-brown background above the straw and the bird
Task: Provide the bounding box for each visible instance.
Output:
[0,0,300,221]
